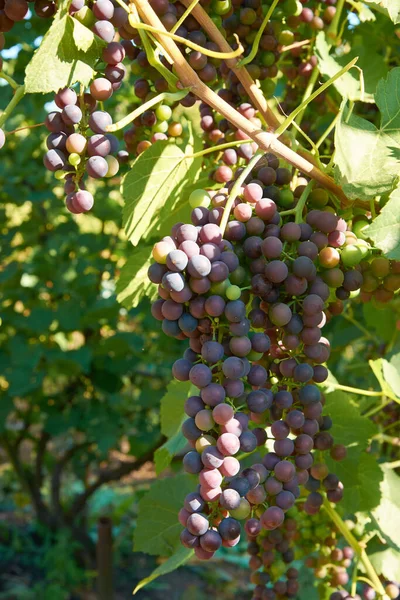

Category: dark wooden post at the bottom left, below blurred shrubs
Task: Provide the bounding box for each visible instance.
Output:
[96,517,114,600]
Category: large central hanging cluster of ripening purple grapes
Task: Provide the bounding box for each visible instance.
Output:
[149,156,363,572]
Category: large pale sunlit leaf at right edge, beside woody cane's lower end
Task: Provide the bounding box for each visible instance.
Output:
[335,67,400,199]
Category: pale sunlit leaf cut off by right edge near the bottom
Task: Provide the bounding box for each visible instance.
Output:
[372,465,400,550]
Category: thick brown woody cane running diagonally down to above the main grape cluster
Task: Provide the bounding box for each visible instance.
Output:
[135,0,351,206]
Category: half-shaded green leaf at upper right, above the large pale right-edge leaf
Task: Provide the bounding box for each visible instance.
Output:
[315,31,387,102]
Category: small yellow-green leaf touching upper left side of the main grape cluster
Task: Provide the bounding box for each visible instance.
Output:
[116,244,157,309]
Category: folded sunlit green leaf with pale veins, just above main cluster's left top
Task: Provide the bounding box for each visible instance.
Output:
[122,141,201,246]
